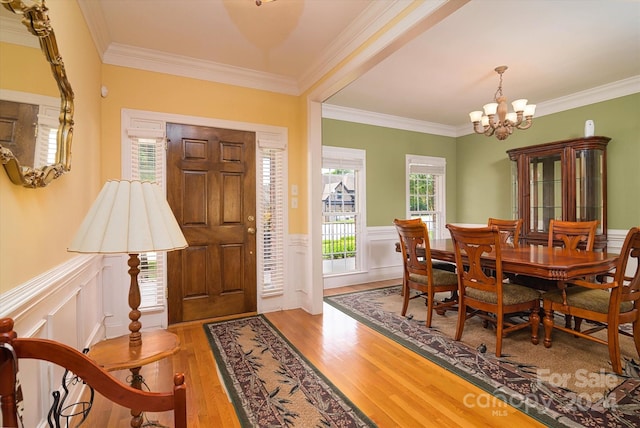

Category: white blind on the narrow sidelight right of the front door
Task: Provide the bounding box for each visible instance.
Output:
[257,139,287,295]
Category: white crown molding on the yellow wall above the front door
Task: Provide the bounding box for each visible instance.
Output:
[103,43,299,95]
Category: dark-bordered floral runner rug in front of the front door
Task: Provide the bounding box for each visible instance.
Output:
[204,316,376,428]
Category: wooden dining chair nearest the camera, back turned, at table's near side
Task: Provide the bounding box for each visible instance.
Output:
[447,224,540,357]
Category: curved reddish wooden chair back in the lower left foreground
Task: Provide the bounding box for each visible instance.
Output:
[0,318,187,428]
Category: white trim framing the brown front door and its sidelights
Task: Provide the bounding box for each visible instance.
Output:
[119,109,294,328]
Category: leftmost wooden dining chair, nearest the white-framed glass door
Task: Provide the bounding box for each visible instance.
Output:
[393,218,458,327]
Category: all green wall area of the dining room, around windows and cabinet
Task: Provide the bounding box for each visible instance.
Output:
[322,93,640,229]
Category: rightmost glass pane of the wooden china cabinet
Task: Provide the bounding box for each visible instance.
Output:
[575,149,604,233]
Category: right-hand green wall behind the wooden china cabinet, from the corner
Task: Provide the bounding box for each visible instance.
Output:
[458,94,640,229]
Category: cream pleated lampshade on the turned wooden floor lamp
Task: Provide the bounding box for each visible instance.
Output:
[68,181,188,254]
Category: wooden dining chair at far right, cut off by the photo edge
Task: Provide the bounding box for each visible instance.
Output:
[542,227,640,374]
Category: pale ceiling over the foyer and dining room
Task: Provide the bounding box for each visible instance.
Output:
[79,0,640,135]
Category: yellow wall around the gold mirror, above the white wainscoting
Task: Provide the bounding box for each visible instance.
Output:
[0,0,102,292]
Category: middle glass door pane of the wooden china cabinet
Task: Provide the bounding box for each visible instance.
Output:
[529,153,563,233]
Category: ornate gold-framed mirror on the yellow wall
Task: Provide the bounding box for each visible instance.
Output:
[0,0,73,188]
